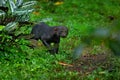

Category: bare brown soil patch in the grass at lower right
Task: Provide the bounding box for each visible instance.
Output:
[67,54,113,74]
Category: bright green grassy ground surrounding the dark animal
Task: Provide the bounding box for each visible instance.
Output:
[0,0,120,80]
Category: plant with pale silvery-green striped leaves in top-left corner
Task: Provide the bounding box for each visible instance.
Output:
[0,0,36,32]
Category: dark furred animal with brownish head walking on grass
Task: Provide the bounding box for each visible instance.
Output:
[31,22,68,53]
